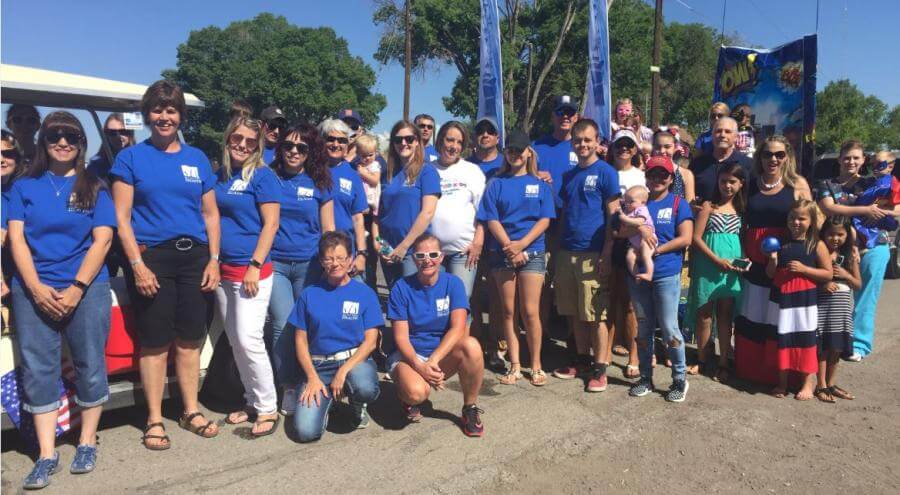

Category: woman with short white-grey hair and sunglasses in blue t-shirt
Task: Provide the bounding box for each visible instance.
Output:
[319,119,369,280]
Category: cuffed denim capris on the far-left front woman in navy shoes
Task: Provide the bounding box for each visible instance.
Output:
[11,281,112,414]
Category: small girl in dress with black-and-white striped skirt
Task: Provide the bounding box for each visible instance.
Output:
[815,216,862,403]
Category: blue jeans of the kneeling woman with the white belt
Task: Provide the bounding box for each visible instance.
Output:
[294,358,381,442]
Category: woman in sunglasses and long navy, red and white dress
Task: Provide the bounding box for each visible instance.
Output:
[734,136,810,385]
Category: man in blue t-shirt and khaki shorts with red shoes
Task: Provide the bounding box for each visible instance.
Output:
[553,119,619,392]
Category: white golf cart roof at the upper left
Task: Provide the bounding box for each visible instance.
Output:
[0,64,203,112]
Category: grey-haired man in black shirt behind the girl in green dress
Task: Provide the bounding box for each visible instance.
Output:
[688,116,753,207]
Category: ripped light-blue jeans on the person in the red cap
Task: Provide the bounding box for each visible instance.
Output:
[626,273,684,380]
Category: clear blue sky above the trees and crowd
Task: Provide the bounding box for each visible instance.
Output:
[0,0,900,136]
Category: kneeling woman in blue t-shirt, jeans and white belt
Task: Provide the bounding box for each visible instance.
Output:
[285,232,384,442]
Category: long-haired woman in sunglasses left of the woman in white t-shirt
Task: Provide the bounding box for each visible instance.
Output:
[372,120,441,287]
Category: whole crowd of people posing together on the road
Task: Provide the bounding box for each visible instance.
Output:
[2,81,900,488]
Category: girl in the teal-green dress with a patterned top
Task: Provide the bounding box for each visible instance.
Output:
[685,164,747,382]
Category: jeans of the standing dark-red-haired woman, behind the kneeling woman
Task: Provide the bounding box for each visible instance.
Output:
[269,258,322,386]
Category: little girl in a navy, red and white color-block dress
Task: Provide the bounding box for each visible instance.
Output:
[766,199,832,400]
